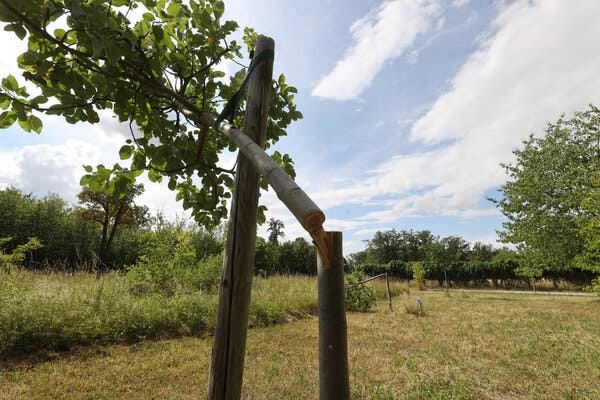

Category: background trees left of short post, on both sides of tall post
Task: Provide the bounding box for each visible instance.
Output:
[0,185,316,275]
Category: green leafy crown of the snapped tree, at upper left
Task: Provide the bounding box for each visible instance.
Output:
[0,0,302,227]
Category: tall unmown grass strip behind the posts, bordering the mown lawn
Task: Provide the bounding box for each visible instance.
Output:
[0,263,401,358]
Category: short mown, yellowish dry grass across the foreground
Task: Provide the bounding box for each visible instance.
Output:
[0,291,600,400]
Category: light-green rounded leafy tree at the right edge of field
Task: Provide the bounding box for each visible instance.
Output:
[492,106,600,275]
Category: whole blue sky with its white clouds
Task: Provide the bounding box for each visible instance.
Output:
[0,0,600,253]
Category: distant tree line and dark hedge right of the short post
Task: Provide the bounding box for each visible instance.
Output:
[348,229,595,287]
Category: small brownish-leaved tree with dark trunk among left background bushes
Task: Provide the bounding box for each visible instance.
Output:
[77,174,148,264]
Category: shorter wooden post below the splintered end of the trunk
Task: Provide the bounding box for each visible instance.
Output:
[317,232,350,400]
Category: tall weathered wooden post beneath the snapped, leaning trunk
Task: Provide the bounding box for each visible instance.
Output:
[207,36,275,400]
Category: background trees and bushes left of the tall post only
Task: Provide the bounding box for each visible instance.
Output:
[0,185,223,271]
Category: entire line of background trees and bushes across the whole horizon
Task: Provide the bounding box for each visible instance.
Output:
[0,187,596,285]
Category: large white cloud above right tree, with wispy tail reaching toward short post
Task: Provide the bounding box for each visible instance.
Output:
[308,0,600,224]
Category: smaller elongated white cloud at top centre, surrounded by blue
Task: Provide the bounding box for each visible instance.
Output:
[312,0,441,100]
